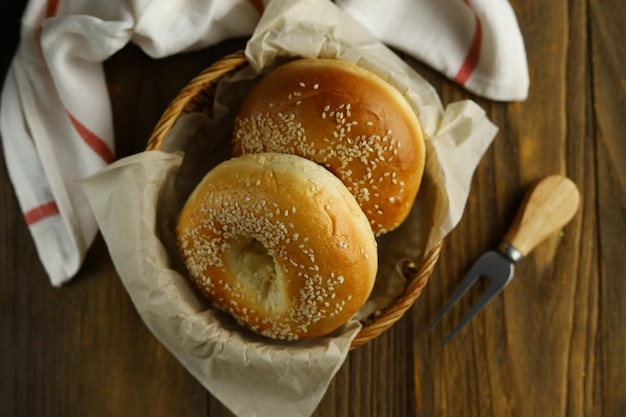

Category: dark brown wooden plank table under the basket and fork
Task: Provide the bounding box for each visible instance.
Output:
[0,0,626,417]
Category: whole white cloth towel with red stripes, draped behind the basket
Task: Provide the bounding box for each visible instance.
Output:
[0,0,528,286]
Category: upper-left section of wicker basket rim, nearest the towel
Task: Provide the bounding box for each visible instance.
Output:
[146,51,248,151]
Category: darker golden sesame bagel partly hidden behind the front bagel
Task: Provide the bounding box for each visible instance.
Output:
[233,59,425,235]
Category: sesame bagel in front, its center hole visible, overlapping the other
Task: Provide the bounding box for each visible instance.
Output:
[176,153,378,340]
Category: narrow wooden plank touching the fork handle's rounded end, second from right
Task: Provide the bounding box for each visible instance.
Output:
[566,1,602,415]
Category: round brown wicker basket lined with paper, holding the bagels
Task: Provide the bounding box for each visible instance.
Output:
[147,51,442,349]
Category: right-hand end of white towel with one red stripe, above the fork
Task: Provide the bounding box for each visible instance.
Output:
[336,0,529,101]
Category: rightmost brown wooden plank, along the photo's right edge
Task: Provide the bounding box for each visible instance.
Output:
[589,1,626,416]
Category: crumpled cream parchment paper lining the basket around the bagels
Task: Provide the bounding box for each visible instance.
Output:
[82,0,497,417]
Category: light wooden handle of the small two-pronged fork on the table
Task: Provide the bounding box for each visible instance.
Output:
[503,175,580,256]
